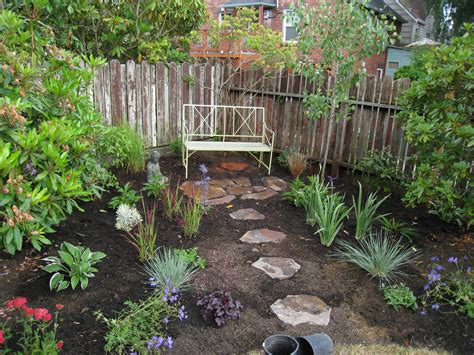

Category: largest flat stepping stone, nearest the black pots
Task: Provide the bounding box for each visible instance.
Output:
[270,295,331,326]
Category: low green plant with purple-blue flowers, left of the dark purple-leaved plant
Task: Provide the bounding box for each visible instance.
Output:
[95,291,180,354]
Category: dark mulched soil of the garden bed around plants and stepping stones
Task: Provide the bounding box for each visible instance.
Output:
[0,154,474,354]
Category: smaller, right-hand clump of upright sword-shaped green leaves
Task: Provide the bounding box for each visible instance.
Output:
[352,182,388,240]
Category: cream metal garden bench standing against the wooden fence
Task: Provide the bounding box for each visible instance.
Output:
[181,104,275,179]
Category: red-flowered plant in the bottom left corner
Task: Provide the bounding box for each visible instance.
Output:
[0,297,63,354]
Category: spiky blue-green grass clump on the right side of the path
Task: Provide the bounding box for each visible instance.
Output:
[335,232,418,283]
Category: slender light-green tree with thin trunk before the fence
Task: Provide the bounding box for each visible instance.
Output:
[294,0,395,175]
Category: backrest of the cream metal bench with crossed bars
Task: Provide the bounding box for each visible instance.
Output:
[181,104,265,141]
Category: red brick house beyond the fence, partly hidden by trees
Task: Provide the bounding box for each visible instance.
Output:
[191,0,433,77]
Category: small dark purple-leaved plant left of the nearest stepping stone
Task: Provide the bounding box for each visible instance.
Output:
[196,290,244,327]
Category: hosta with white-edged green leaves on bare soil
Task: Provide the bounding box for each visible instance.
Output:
[43,242,106,292]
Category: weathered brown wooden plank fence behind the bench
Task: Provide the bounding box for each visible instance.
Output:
[93,61,410,170]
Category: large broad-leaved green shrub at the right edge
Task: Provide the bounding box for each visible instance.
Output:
[398,25,474,226]
